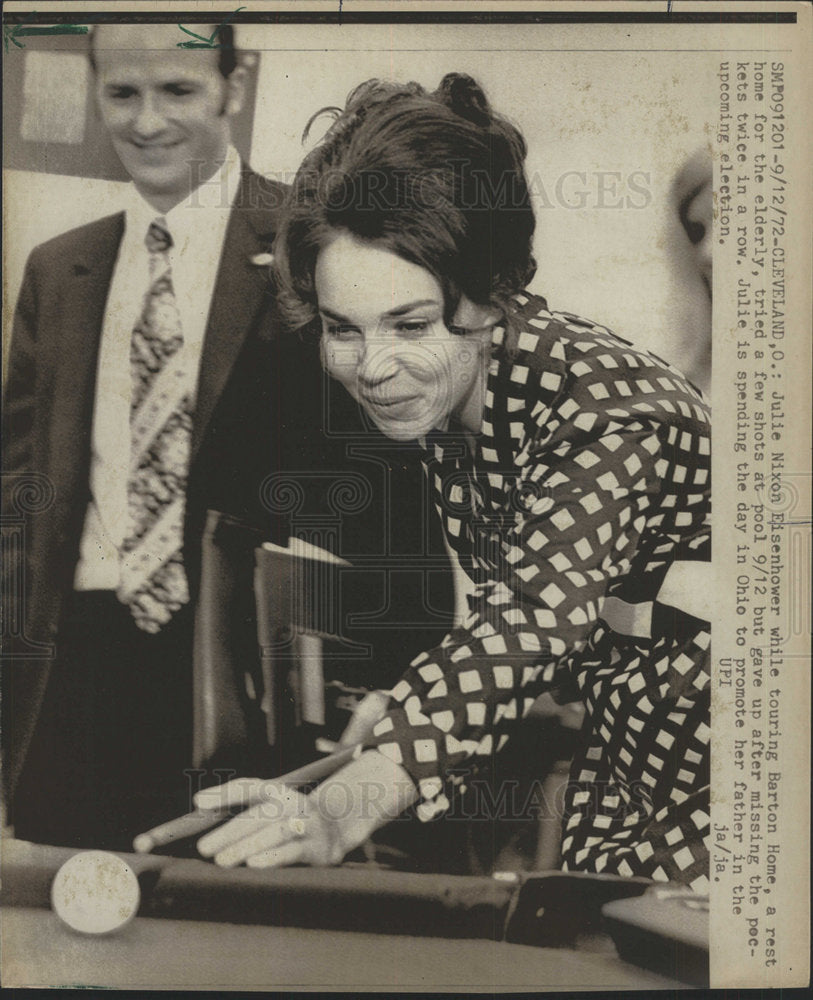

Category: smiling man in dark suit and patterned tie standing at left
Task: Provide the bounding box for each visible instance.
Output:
[3,25,298,848]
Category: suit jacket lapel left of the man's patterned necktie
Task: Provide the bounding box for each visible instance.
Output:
[51,214,124,504]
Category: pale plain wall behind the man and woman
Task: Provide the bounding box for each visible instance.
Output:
[4,25,716,384]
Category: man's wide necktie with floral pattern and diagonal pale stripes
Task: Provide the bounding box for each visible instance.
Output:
[118,219,192,632]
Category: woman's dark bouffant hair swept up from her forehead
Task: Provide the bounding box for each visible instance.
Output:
[275,73,536,327]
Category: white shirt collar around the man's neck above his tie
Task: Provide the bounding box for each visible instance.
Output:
[120,145,241,246]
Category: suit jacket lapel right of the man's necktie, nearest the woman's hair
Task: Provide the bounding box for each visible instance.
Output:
[192,170,276,461]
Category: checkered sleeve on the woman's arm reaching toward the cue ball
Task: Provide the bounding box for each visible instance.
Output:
[368,423,666,819]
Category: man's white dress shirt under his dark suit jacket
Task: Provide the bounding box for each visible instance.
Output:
[74,146,240,590]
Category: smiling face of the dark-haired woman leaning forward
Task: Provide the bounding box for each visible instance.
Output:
[314,231,493,441]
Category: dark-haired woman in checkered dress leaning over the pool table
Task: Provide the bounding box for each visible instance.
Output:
[197,74,710,890]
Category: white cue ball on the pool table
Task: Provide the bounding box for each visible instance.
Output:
[51,851,141,934]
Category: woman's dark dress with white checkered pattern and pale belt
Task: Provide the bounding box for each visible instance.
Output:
[368,294,710,891]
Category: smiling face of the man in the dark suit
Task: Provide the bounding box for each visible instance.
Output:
[94,25,243,212]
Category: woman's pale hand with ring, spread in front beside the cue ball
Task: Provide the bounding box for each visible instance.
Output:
[195,750,417,868]
